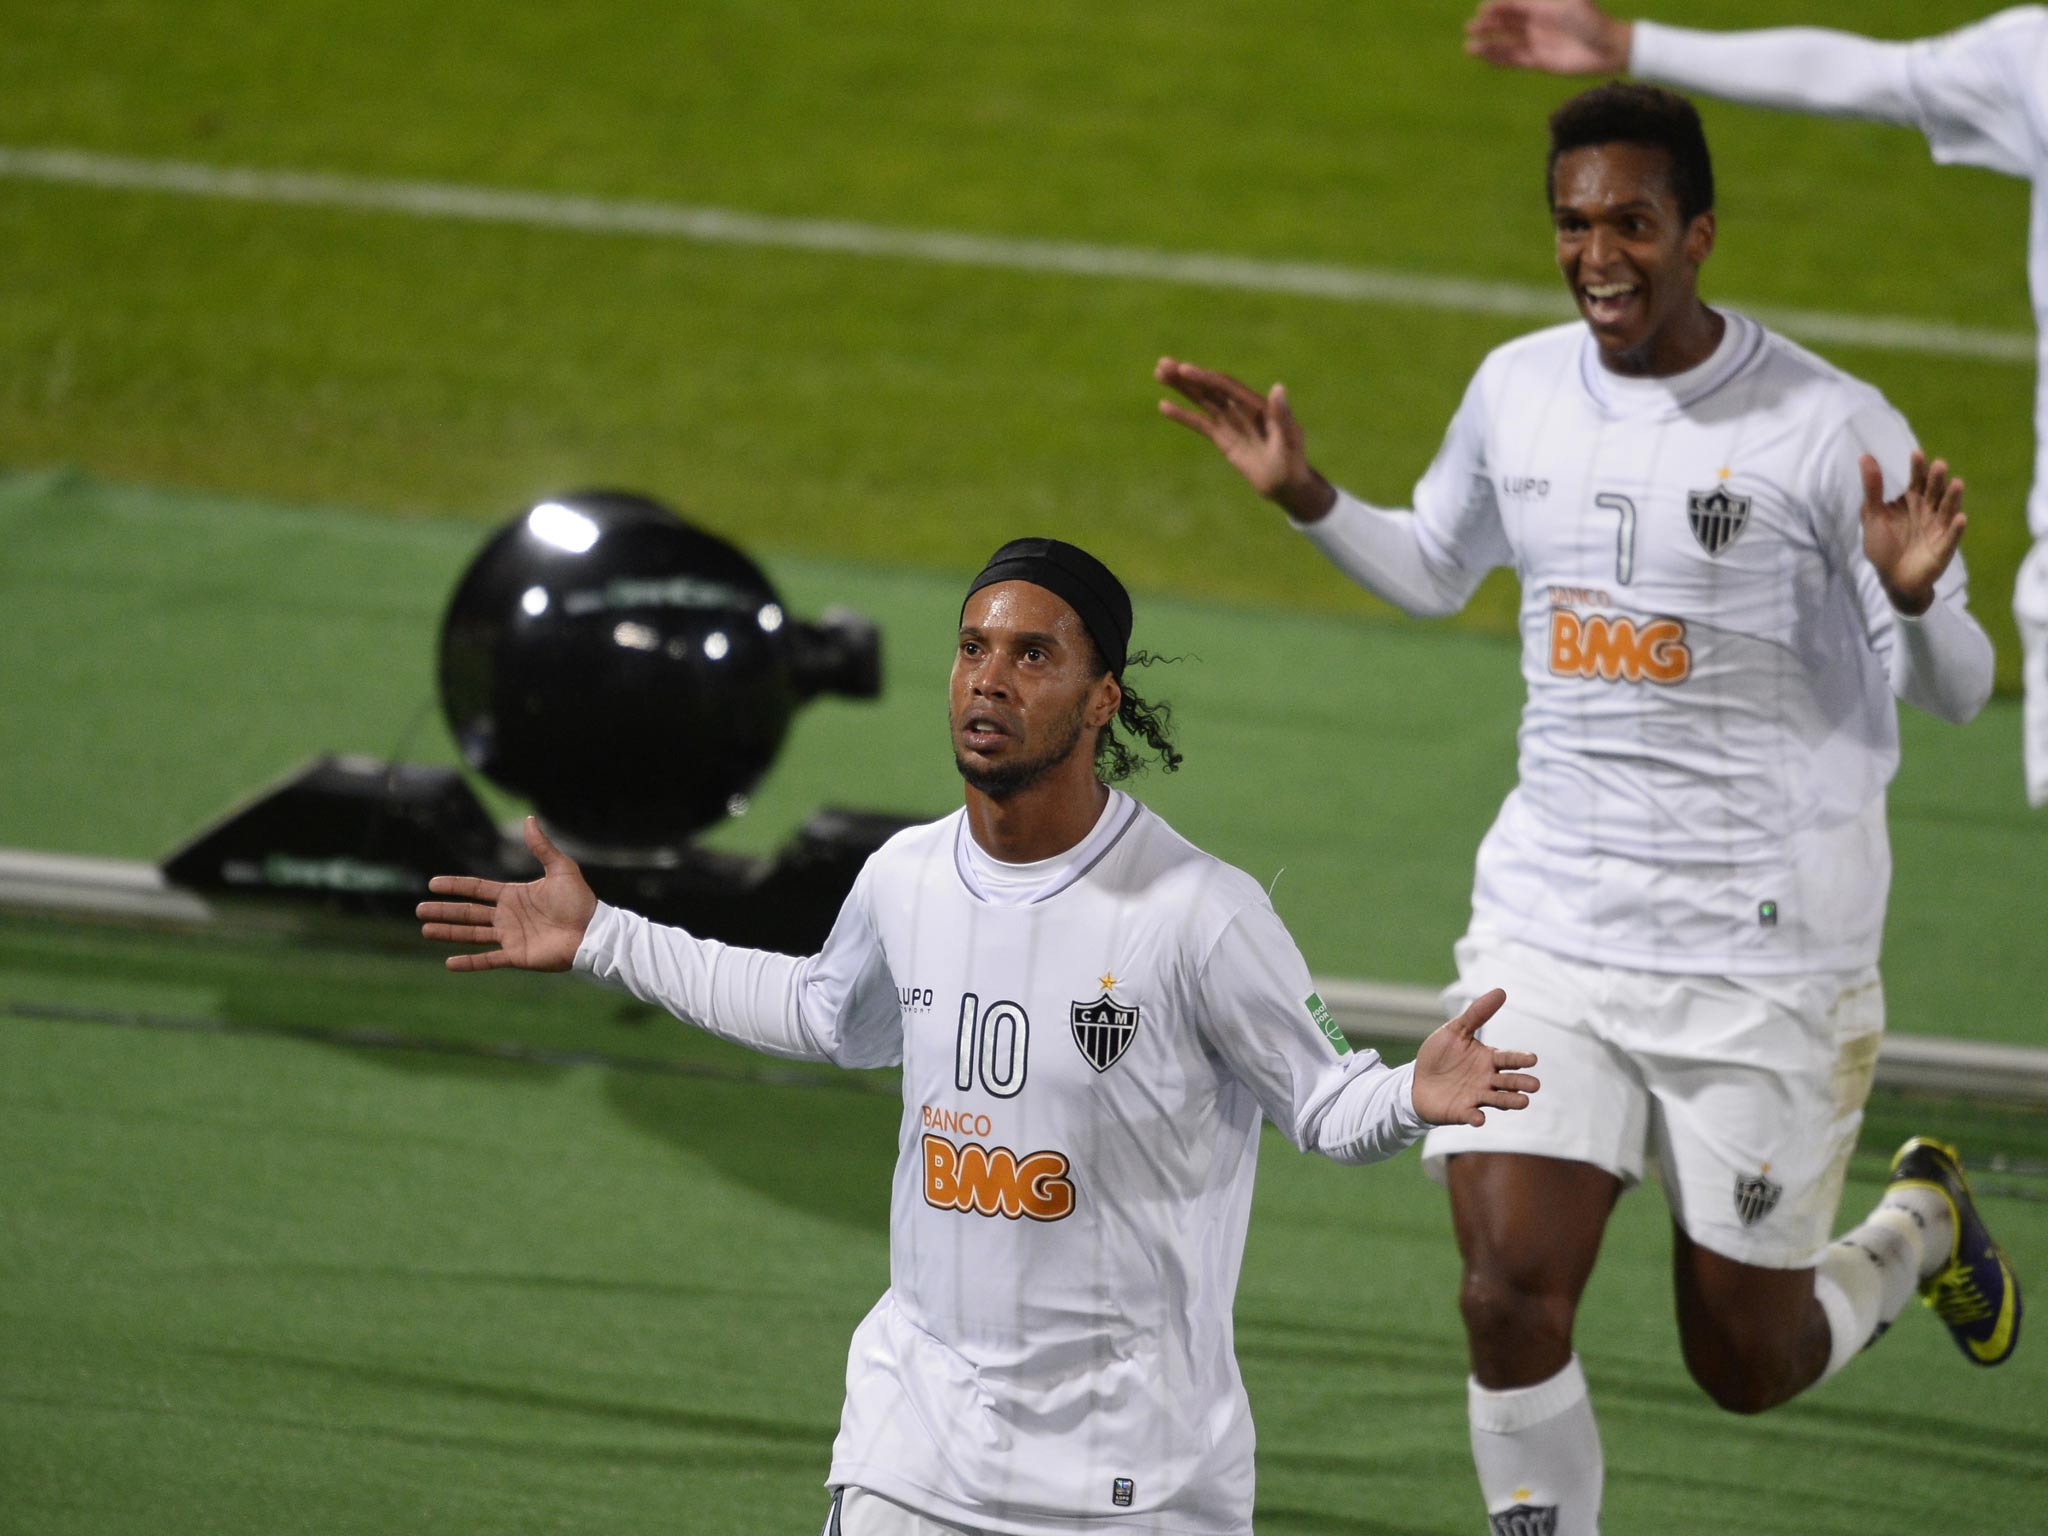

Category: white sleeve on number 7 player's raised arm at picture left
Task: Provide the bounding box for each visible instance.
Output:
[1294,377,1513,618]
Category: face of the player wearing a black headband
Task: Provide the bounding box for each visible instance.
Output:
[950,582,1122,799]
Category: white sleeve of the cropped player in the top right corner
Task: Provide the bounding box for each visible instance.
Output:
[1628,6,2048,176]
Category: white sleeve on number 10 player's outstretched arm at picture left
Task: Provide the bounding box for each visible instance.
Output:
[575,870,903,1067]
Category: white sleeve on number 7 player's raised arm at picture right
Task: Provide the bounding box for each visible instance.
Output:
[1810,399,1995,725]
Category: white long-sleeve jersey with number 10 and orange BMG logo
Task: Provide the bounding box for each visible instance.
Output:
[575,793,1423,1536]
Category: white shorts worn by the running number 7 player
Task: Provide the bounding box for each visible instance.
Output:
[1421,930,1884,1270]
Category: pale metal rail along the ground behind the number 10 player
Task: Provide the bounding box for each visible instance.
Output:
[0,848,2048,1106]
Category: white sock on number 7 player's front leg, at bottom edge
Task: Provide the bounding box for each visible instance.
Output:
[1466,1356,1604,1536]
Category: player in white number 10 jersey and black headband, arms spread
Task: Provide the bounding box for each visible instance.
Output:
[420,539,1536,1536]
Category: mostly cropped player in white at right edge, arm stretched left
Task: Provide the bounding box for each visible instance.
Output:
[1466,0,2048,819]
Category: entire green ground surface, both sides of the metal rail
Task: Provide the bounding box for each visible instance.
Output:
[0,0,2048,1536]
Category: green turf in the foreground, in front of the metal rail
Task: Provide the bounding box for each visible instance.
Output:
[0,920,2048,1536]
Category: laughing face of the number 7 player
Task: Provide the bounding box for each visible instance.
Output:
[1550,143,1714,375]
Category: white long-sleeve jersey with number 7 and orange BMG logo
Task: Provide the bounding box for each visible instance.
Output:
[1305,313,1993,975]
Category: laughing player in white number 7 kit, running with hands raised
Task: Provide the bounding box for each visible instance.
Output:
[1155,86,2019,1536]
